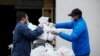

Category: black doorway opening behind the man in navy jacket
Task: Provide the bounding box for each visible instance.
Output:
[0,5,42,56]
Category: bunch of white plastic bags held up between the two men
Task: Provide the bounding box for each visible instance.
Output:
[38,16,55,41]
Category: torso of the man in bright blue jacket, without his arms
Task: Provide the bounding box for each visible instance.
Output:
[72,19,90,55]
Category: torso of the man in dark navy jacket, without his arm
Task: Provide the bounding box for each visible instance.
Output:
[12,23,31,56]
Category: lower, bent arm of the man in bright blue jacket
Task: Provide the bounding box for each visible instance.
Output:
[59,23,85,42]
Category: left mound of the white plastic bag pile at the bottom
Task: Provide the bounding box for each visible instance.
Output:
[31,43,56,56]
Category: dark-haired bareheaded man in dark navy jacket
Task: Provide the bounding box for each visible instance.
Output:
[12,12,43,56]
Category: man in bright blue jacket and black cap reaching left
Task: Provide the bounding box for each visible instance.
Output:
[51,8,90,56]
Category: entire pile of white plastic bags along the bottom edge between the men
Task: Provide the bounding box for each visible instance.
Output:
[31,43,75,56]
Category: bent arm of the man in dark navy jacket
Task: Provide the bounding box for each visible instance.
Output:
[20,25,43,40]
